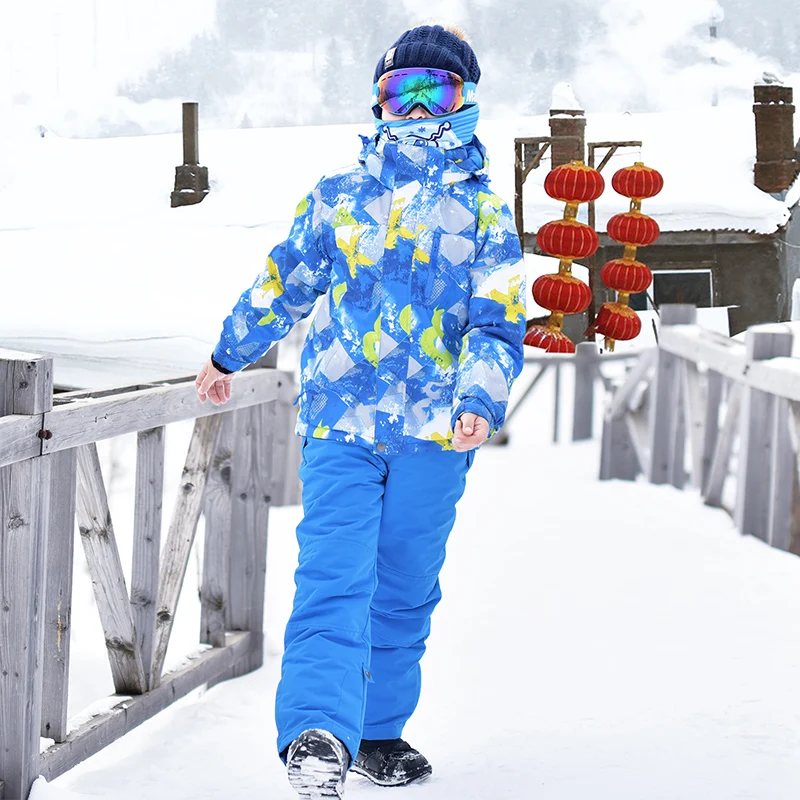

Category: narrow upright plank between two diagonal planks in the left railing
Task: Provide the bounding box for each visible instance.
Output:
[131,426,164,689]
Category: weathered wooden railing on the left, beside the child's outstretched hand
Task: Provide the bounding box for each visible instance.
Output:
[0,351,299,800]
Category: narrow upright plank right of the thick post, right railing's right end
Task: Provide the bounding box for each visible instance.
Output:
[767,397,796,550]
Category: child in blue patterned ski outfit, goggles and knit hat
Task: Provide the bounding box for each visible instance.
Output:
[197,25,525,798]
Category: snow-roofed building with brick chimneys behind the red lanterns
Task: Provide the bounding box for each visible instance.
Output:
[515,83,800,334]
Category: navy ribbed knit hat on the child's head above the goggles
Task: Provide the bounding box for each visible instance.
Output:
[373,25,481,83]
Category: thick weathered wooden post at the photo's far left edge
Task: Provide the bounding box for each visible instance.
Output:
[0,357,53,800]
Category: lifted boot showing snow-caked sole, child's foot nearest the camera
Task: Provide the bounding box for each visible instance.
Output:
[286,728,350,800]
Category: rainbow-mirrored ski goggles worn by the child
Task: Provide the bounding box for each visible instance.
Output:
[372,67,477,117]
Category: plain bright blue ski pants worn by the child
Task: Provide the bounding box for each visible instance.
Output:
[275,438,474,757]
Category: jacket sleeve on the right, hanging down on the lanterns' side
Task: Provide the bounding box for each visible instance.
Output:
[452,193,526,436]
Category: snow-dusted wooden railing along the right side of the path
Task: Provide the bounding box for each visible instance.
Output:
[600,306,800,553]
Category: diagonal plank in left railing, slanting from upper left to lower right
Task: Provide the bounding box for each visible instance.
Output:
[77,444,147,694]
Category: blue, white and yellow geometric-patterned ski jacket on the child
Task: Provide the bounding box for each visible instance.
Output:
[213,136,525,454]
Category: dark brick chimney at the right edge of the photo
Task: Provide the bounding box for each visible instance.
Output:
[753,83,800,194]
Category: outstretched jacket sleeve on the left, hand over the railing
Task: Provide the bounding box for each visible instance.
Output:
[212,186,331,372]
